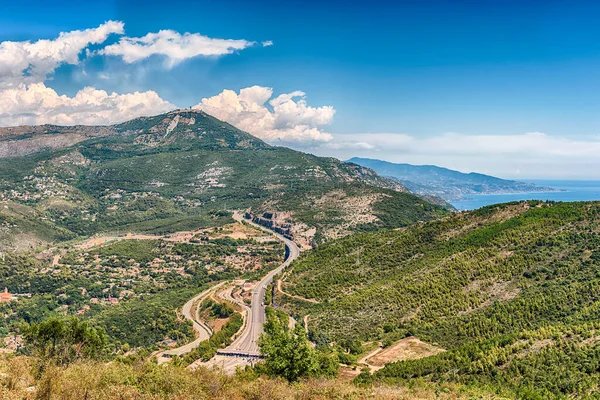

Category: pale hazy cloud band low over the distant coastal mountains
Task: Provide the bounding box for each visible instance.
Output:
[310,132,600,179]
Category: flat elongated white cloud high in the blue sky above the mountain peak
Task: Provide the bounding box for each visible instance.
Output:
[99,30,255,68]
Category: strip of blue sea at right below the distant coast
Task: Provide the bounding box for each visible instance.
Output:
[450,180,600,210]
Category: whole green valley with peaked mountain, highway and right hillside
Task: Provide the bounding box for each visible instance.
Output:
[0,110,600,399]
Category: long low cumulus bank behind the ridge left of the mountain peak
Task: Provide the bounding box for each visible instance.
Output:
[0,83,175,126]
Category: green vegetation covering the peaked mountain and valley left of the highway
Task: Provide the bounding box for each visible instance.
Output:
[0,111,446,354]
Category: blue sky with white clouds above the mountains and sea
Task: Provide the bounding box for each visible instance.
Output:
[0,0,600,179]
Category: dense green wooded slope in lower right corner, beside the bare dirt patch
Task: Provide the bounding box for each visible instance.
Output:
[372,322,600,399]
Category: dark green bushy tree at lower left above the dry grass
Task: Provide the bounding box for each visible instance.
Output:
[23,317,106,364]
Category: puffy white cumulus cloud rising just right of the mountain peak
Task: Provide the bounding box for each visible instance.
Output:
[194,86,335,145]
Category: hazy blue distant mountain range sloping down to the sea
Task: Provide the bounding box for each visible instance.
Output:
[348,157,556,201]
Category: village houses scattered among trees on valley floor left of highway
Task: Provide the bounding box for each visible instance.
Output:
[0,219,283,351]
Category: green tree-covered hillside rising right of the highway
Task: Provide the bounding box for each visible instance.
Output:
[276,201,600,399]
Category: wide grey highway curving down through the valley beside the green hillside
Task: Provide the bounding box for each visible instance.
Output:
[223,212,300,355]
